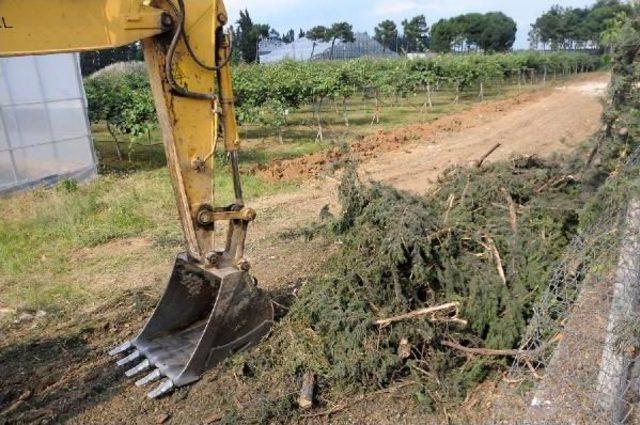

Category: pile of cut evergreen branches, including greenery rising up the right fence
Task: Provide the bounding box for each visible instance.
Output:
[219,21,640,422]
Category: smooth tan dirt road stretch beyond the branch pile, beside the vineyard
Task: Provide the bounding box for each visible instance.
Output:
[363,77,607,192]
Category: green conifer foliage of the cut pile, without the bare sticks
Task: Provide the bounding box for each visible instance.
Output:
[244,158,581,410]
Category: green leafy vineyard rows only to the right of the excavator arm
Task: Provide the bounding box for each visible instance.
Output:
[234,52,601,127]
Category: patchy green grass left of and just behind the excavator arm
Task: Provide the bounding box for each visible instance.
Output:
[0,163,292,311]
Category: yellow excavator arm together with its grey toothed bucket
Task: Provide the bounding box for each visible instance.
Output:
[0,0,273,398]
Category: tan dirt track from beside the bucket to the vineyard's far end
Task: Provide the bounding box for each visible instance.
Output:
[249,74,609,287]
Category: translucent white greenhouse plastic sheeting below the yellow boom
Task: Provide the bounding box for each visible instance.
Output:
[0,54,96,193]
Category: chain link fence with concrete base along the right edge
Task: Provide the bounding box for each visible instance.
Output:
[510,21,640,424]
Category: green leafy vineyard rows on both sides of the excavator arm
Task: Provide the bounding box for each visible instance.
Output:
[85,50,601,137]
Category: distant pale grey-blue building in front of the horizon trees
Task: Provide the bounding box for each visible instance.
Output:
[260,33,398,63]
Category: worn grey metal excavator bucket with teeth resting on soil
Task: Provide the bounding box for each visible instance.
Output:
[109,255,274,398]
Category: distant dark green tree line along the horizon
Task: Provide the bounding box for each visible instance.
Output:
[81,0,632,75]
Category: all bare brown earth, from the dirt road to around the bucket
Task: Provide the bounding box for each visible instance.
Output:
[0,74,609,424]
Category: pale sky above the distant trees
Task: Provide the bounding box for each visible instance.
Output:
[225,0,595,48]
